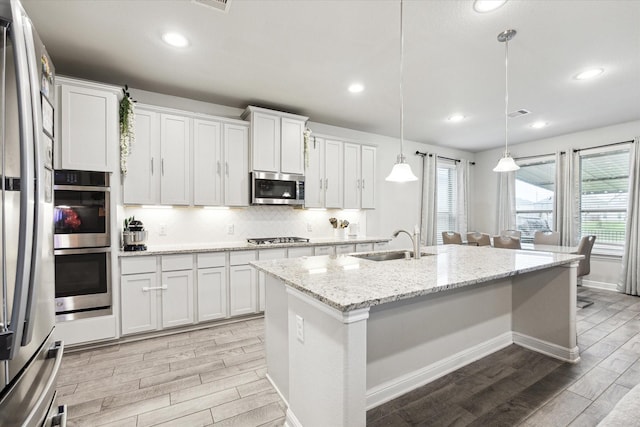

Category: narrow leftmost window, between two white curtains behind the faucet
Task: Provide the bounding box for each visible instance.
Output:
[436,159,458,245]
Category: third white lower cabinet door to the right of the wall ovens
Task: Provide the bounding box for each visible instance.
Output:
[198,267,227,322]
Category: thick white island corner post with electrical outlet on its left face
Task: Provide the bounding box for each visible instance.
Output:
[287,288,369,427]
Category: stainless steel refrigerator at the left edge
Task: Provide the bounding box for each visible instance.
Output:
[0,0,65,427]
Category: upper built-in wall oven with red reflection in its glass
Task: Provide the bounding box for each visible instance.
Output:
[53,170,111,249]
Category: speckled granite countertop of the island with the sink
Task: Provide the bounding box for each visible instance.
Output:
[250,245,583,312]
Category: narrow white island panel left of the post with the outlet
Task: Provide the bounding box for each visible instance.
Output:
[264,274,289,404]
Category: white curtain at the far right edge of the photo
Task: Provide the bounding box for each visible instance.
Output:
[618,137,640,295]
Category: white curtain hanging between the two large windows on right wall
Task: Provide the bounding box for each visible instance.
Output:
[554,149,580,246]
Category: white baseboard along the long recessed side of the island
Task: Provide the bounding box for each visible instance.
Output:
[366,332,513,410]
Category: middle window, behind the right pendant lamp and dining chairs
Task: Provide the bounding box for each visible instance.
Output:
[516,157,556,242]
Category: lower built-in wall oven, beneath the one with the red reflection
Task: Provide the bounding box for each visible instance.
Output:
[55,247,111,321]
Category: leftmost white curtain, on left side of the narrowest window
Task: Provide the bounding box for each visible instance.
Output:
[420,153,438,246]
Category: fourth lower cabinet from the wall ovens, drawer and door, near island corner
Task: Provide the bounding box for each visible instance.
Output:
[229,251,258,316]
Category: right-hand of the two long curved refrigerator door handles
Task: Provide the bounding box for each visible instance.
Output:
[21,15,45,346]
